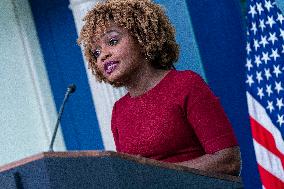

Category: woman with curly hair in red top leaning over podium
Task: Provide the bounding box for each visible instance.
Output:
[78,0,240,175]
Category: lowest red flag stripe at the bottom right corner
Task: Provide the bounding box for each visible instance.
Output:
[258,165,284,189]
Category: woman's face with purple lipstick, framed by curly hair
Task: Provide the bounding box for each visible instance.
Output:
[92,24,145,84]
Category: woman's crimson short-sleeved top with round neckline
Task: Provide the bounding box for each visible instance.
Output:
[111,70,237,162]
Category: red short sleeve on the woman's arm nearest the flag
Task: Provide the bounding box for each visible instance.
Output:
[186,75,237,154]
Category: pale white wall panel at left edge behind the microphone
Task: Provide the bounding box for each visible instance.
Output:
[0,0,65,165]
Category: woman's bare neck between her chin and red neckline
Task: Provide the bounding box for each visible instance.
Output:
[125,66,170,97]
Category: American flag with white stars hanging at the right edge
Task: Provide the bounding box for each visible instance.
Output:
[245,0,284,189]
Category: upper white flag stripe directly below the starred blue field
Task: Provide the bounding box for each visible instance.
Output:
[247,92,284,154]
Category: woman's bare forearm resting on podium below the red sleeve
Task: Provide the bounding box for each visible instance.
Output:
[176,146,241,176]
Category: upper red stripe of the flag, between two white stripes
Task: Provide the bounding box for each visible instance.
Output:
[250,117,284,158]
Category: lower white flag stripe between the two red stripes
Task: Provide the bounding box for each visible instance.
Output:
[253,139,284,182]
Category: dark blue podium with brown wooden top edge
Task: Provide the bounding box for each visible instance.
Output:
[0,151,243,189]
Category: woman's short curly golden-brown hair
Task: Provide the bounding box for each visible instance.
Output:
[77,0,179,82]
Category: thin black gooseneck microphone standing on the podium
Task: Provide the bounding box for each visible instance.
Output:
[49,84,76,152]
